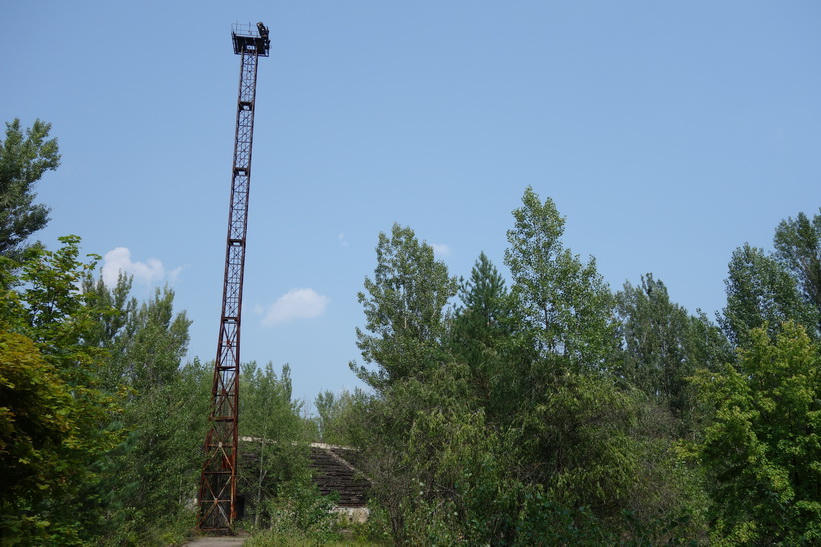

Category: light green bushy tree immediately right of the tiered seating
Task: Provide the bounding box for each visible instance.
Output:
[350,365,506,544]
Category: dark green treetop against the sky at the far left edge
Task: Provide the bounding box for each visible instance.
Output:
[0,119,60,257]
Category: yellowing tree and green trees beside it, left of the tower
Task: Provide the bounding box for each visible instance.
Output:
[0,236,200,545]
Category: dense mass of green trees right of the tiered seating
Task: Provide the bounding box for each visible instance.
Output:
[334,188,821,545]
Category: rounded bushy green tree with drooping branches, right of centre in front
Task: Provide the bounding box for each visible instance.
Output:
[518,372,688,525]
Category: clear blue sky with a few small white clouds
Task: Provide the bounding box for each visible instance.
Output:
[0,0,821,401]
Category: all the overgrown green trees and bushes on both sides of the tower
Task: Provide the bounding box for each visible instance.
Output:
[0,121,821,545]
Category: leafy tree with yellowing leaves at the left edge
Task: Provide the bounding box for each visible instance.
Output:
[0,236,120,544]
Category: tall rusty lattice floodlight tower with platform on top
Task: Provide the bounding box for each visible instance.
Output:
[197,23,271,533]
